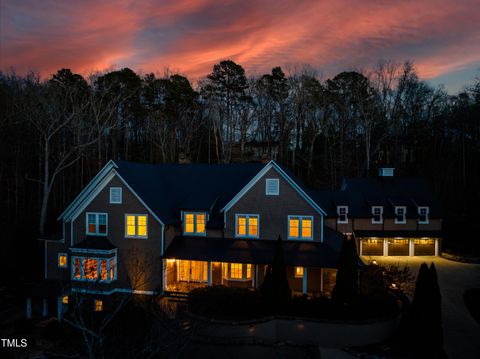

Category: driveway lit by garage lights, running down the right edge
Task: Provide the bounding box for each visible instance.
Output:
[363,257,480,359]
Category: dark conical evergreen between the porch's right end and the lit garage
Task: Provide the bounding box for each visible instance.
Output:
[332,237,359,304]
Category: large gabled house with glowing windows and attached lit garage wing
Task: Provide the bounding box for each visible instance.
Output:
[34,161,441,313]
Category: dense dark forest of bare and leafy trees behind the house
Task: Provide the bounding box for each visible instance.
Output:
[0,61,480,284]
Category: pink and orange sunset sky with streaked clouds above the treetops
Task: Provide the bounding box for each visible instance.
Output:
[0,0,480,93]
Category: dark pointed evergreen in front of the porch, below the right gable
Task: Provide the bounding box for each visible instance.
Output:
[260,236,292,312]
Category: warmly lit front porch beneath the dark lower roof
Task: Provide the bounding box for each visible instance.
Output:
[163,259,336,297]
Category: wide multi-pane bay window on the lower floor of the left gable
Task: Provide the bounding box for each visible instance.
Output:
[72,256,117,282]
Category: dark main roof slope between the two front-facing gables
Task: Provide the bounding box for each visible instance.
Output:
[115,161,265,225]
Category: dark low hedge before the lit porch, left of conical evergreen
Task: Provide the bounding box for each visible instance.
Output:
[188,285,266,320]
